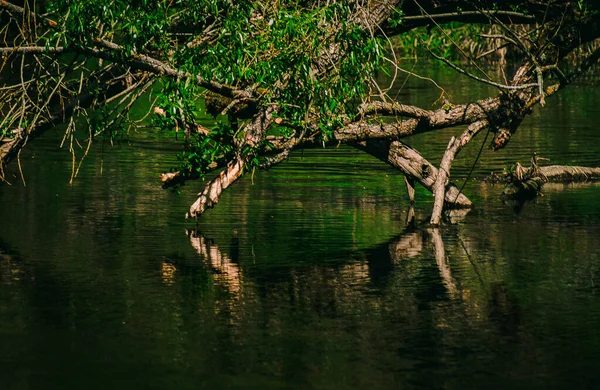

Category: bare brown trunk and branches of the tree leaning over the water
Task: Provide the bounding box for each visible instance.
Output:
[0,0,600,225]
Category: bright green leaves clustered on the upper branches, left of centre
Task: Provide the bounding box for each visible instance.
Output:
[38,0,394,177]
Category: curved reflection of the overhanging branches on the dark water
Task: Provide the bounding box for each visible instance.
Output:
[183,213,464,305]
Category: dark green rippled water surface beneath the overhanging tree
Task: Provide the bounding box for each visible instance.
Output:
[0,65,600,389]
